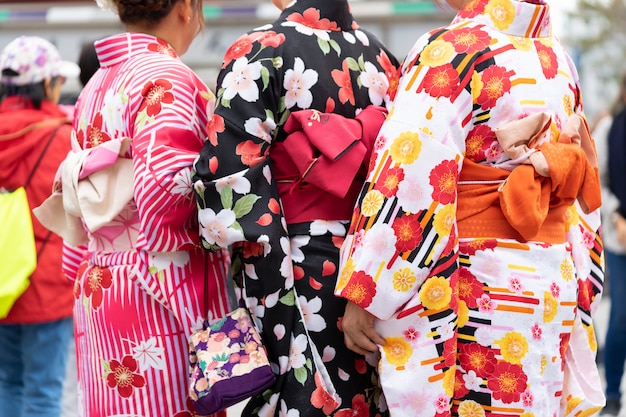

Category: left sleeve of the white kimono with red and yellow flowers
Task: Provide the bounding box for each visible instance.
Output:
[335,34,472,320]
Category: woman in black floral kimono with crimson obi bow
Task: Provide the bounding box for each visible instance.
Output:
[194,0,398,417]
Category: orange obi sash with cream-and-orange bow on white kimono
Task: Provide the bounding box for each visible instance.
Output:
[457,113,601,243]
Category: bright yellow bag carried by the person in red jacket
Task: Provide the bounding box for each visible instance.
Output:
[0,187,37,319]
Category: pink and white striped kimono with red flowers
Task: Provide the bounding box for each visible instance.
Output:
[64,33,229,417]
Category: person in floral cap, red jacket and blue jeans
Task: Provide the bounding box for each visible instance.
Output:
[0,36,79,417]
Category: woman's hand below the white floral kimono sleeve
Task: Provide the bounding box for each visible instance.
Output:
[342,301,385,355]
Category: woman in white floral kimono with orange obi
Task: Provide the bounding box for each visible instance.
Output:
[336,0,604,417]
